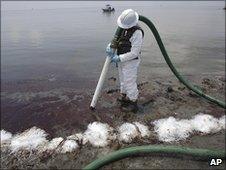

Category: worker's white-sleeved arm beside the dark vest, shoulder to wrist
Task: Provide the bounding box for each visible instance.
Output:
[119,30,143,62]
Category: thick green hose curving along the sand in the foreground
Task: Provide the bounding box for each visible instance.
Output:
[84,145,225,169]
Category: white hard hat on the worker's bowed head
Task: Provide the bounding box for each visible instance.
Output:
[117,9,139,29]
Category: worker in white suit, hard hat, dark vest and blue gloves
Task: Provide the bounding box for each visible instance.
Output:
[106,9,144,112]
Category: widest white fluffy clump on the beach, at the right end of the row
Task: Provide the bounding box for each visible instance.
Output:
[153,113,225,142]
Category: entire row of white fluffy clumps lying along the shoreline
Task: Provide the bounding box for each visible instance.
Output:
[1,113,225,153]
